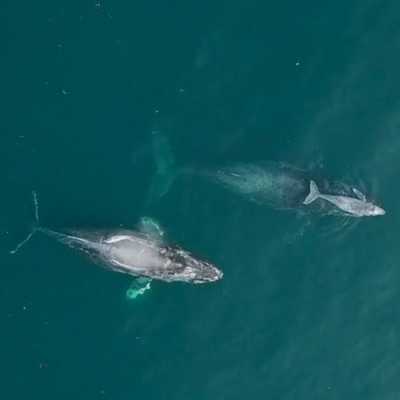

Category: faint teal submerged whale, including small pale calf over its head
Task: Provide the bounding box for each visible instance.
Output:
[144,131,385,217]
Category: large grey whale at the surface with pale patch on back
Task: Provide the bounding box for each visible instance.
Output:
[11,194,223,284]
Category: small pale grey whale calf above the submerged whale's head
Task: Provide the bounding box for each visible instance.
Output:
[303,180,386,217]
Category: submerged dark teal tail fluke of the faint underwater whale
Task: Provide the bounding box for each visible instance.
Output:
[147,131,178,205]
